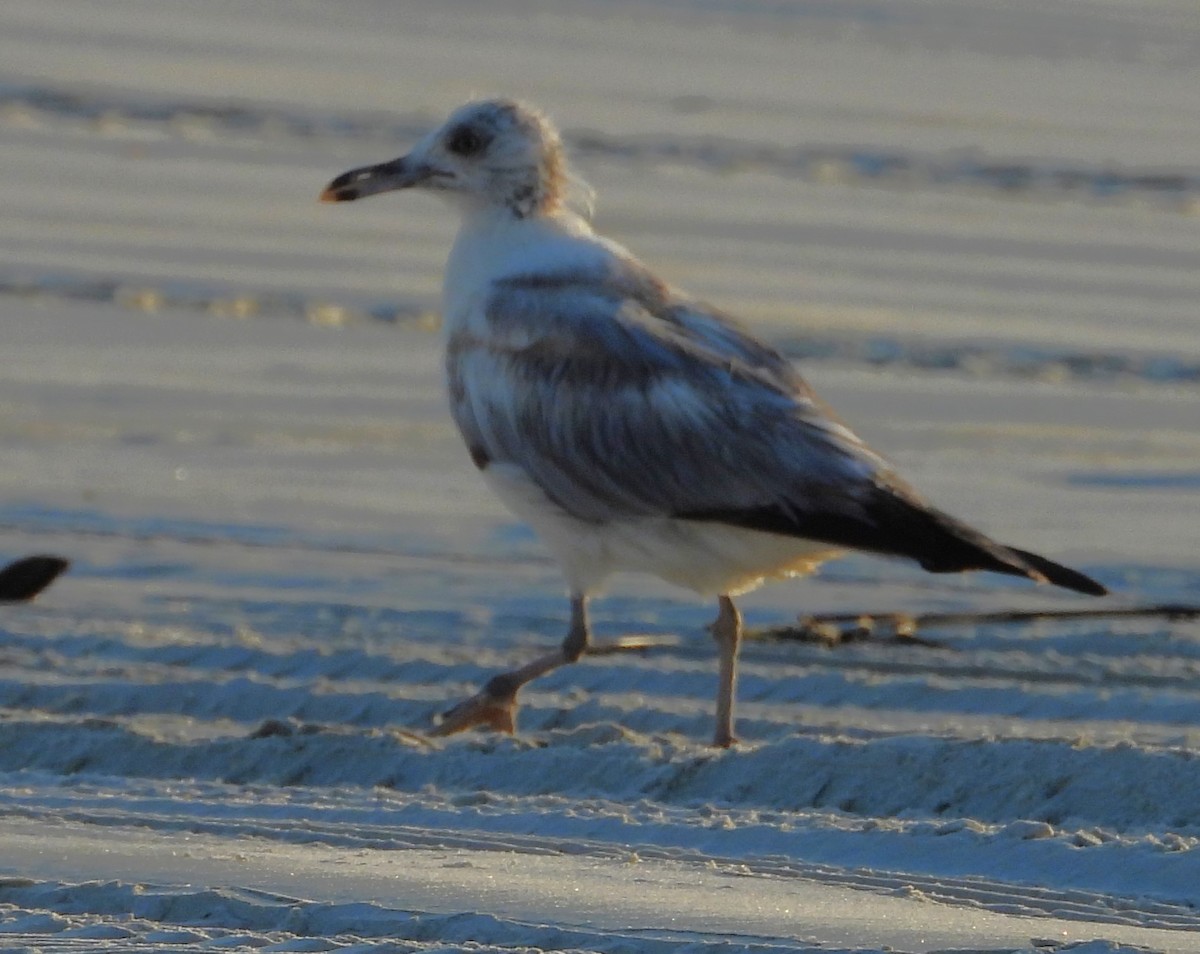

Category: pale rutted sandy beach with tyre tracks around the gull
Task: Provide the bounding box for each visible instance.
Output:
[0,0,1200,954]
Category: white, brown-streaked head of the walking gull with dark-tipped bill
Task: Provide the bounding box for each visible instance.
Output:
[320,100,568,218]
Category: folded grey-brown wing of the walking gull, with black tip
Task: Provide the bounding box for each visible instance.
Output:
[448,276,1098,592]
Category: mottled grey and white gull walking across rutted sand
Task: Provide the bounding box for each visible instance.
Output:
[322,98,1106,748]
